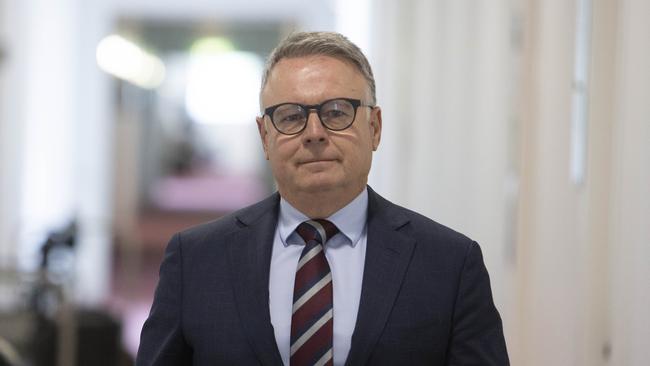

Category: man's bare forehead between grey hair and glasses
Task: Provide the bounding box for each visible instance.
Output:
[262,56,369,106]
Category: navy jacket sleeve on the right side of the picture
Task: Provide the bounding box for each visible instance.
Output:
[446,242,510,366]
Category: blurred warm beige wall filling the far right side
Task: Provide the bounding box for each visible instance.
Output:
[514,0,650,365]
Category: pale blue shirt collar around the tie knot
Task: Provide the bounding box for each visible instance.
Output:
[278,188,368,247]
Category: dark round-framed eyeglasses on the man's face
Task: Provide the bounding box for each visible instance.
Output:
[264,98,375,135]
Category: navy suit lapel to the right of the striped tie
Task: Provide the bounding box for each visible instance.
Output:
[346,188,415,365]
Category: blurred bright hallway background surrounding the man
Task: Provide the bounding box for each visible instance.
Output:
[0,0,650,366]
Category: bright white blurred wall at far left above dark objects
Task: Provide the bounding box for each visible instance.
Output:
[0,0,111,304]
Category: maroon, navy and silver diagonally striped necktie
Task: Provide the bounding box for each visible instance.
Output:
[290,219,339,366]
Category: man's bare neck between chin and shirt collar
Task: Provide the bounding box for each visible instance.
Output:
[280,185,366,219]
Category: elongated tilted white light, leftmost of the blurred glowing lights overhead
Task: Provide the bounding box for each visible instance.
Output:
[96,35,165,89]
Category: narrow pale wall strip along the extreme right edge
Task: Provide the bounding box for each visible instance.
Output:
[608,0,650,366]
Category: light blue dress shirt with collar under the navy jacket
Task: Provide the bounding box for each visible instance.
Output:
[269,189,368,365]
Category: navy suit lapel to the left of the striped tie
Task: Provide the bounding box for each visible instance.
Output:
[228,197,282,365]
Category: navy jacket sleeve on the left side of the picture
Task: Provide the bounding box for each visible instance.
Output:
[136,234,192,366]
